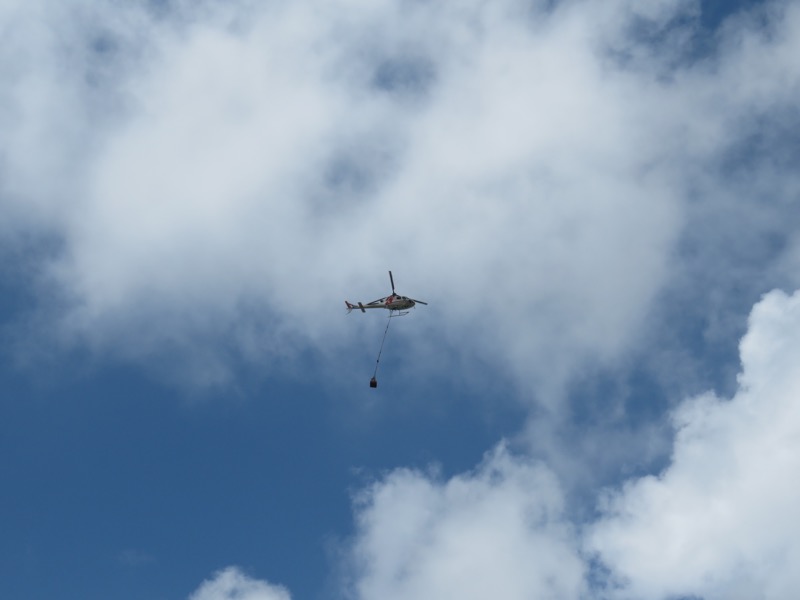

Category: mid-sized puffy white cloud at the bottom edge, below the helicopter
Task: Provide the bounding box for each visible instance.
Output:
[352,444,584,600]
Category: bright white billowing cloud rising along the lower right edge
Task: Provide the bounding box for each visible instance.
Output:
[589,292,800,600]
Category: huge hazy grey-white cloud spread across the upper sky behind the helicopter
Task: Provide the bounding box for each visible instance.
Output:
[0,0,798,398]
